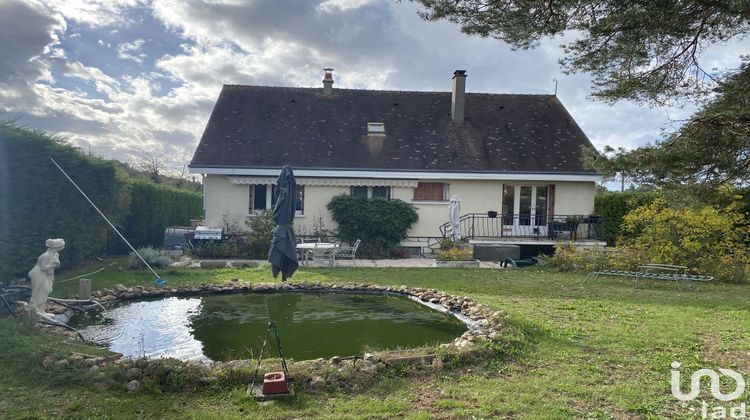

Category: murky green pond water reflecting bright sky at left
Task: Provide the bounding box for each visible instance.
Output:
[70,293,467,361]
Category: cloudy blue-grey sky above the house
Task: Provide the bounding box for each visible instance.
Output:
[0,0,750,172]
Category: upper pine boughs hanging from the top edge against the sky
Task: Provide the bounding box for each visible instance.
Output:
[413,0,750,104]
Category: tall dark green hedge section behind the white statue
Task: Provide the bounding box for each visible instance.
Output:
[0,122,130,280]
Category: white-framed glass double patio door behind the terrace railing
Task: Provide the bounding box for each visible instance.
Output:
[503,185,549,237]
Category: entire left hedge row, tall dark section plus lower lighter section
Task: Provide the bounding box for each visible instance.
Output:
[0,121,202,282]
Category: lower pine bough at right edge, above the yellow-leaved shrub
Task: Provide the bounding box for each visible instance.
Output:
[585,63,750,193]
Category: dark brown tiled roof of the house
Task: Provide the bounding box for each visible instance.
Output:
[190,85,591,173]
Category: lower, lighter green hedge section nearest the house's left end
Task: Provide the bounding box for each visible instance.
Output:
[125,181,203,247]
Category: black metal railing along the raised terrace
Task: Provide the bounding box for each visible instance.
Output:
[439,213,604,240]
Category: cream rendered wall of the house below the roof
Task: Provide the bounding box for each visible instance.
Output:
[204,175,596,240]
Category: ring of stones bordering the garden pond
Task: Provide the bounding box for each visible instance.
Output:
[43,278,506,391]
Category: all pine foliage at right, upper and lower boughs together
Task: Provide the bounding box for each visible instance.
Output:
[412,0,750,192]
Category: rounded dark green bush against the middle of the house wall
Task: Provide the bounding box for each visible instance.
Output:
[326,195,418,257]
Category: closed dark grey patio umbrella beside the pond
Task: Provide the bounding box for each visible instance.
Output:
[268,165,299,281]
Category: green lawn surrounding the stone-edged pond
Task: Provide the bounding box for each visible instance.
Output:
[0,262,750,419]
